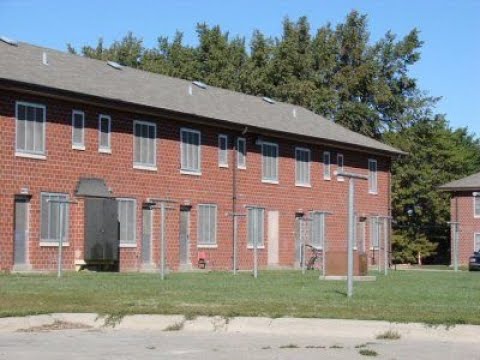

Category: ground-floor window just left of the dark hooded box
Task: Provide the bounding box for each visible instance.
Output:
[40,193,68,245]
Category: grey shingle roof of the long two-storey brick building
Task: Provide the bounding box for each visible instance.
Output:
[0,41,404,155]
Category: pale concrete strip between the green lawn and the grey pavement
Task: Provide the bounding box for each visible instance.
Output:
[0,313,480,343]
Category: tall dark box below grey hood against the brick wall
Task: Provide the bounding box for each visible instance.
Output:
[84,197,120,264]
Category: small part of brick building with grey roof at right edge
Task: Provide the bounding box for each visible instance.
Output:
[440,173,480,265]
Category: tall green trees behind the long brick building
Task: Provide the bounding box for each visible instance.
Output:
[67,11,480,262]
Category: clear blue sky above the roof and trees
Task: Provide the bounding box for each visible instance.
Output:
[0,0,480,136]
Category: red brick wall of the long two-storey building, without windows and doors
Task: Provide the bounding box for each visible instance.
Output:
[0,92,390,270]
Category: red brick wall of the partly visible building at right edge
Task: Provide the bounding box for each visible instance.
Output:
[450,193,480,265]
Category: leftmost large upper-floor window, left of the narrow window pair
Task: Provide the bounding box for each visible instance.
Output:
[15,102,46,157]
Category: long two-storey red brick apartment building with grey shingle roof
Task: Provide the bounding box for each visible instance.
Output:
[0,41,401,271]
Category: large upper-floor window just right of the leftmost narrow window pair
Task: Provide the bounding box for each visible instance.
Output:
[133,121,157,169]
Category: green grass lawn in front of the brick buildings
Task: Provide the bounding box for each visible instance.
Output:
[0,271,480,324]
